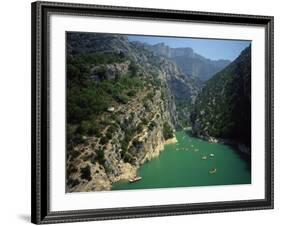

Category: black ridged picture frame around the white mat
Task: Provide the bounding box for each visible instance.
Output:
[31,2,274,224]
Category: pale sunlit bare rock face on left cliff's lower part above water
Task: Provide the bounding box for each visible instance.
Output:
[68,85,171,192]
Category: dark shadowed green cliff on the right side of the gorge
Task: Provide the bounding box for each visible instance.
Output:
[191,46,251,146]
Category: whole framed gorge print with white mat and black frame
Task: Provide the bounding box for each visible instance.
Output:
[32,2,273,224]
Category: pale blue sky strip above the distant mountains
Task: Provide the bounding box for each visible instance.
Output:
[128,35,251,61]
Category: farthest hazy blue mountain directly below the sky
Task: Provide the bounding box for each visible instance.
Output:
[151,43,230,81]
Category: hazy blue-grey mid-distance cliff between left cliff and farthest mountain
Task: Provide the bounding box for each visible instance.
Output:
[129,42,203,127]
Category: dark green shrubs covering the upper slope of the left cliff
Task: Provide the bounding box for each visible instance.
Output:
[67,53,144,148]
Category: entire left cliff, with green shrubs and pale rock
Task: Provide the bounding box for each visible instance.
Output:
[67,33,182,192]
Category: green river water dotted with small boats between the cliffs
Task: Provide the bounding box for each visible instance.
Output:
[112,131,251,190]
